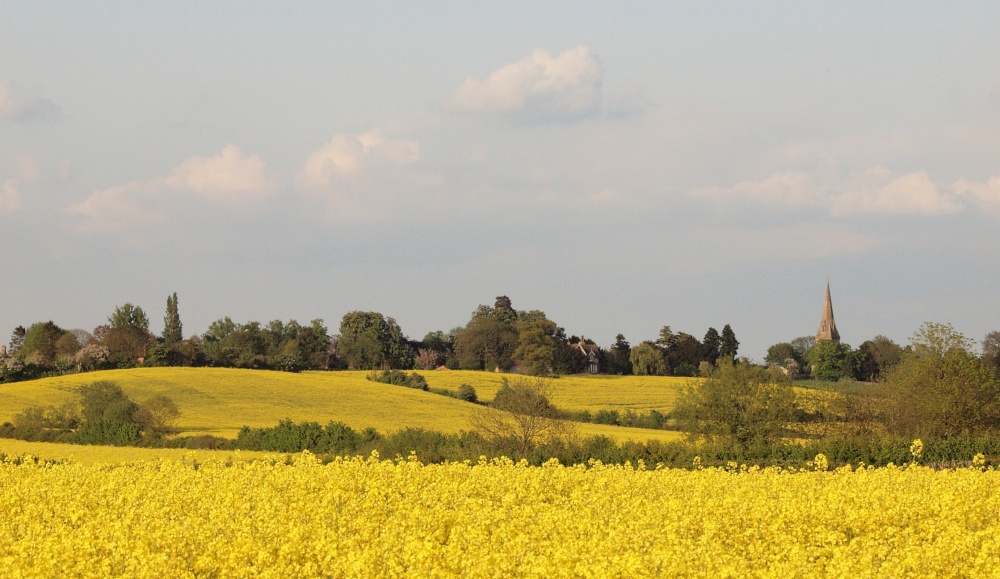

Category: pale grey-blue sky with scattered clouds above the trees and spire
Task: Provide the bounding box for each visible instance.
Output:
[0,1,1000,361]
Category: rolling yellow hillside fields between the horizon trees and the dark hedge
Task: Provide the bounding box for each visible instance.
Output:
[0,368,681,441]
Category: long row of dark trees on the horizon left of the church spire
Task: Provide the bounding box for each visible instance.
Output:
[0,293,739,382]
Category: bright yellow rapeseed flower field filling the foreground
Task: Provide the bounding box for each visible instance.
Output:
[0,453,1000,577]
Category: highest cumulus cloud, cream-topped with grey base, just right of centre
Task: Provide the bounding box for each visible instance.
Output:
[449,46,604,121]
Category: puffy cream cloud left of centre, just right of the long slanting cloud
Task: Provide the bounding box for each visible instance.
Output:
[296,129,444,222]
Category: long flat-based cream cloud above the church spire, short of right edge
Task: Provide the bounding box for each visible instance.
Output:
[695,167,965,216]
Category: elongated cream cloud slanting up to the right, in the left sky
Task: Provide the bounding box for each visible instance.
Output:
[69,145,277,232]
